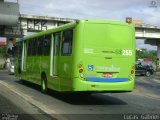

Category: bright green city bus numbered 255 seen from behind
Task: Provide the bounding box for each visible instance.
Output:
[15,20,135,92]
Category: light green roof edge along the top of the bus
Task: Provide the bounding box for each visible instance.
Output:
[24,20,133,40]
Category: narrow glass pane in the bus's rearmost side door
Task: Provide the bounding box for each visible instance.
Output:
[53,32,61,56]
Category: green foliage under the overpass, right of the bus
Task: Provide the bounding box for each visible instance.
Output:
[136,50,157,62]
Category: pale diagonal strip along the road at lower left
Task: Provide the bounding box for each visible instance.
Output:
[0,81,68,120]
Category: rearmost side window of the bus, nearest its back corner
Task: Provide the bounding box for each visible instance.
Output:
[61,30,73,56]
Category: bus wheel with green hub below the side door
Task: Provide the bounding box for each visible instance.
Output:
[41,75,47,94]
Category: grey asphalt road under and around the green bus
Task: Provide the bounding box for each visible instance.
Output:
[0,71,160,120]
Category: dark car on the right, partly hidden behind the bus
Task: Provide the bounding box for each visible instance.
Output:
[136,64,154,76]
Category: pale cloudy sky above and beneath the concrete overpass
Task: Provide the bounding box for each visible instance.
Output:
[5,0,160,50]
